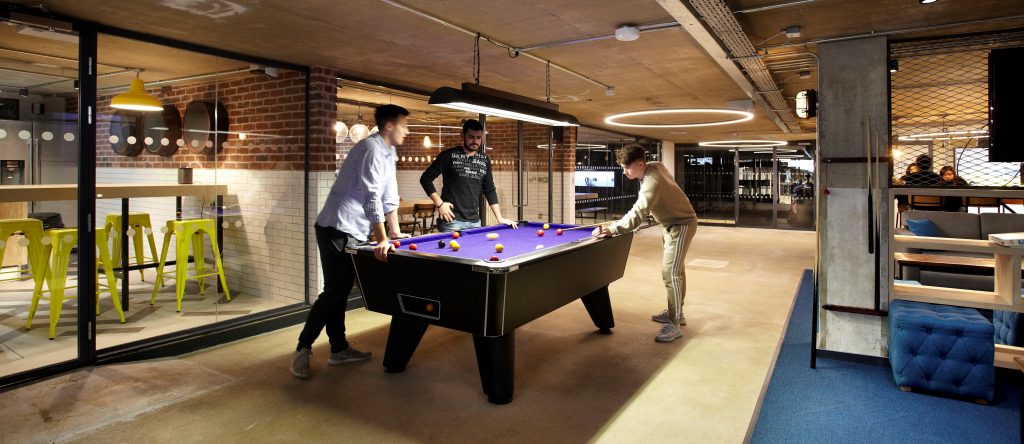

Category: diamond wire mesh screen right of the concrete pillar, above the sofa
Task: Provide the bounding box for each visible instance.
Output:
[889,32,1024,187]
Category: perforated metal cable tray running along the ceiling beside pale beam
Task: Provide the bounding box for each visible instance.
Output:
[689,0,802,133]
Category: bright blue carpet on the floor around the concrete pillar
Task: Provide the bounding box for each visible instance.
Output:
[751,270,1020,444]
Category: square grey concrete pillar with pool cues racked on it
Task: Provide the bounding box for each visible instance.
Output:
[818,37,891,356]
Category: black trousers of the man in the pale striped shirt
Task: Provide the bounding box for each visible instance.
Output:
[295,225,355,353]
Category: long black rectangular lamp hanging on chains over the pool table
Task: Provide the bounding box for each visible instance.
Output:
[428,83,580,127]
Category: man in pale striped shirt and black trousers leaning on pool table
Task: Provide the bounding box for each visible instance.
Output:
[292,104,409,379]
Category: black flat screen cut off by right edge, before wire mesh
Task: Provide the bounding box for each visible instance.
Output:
[988,48,1024,162]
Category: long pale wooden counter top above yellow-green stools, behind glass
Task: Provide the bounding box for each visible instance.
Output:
[0,183,227,202]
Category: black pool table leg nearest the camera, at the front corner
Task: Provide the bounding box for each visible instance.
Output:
[473,330,515,404]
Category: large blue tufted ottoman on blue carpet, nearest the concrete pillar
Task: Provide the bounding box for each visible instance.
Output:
[889,300,995,401]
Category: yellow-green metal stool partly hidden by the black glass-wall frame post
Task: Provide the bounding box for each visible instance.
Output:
[25,228,125,340]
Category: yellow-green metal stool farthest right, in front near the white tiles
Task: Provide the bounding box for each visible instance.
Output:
[150,219,231,313]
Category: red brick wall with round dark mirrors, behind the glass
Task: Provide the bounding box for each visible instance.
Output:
[96,71,309,171]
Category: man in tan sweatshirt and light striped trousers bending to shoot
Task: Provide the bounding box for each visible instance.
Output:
[593,145,697,342]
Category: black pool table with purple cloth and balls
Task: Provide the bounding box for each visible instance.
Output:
[346,222,633,404]
